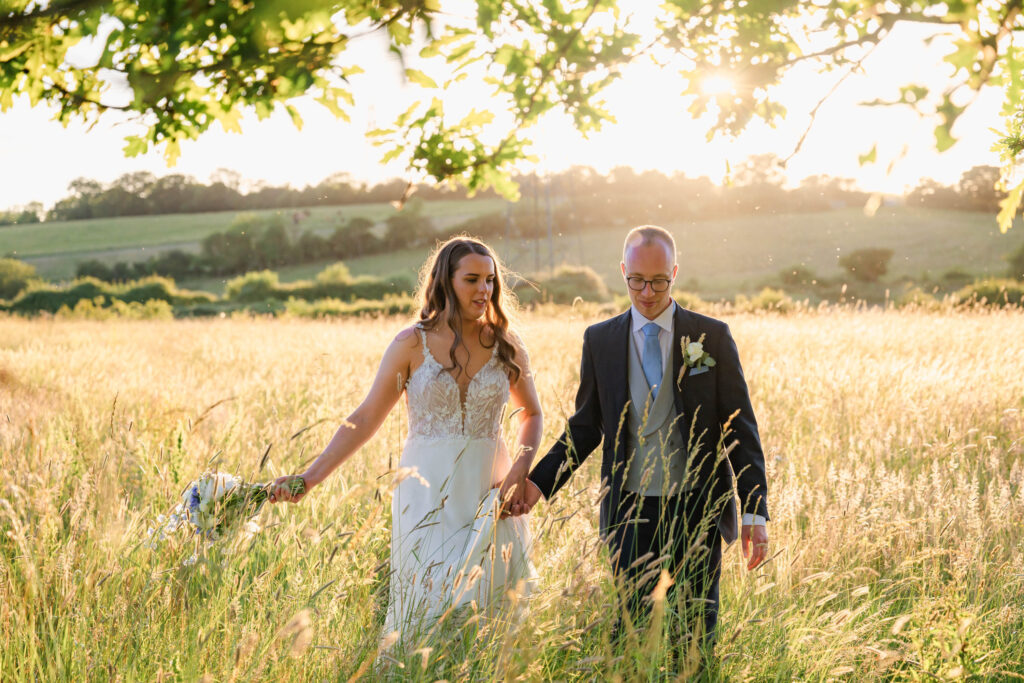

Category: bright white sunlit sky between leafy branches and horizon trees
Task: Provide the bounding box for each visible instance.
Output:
[0,10,1000,210]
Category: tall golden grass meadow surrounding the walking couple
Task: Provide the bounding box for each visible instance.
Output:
[0,311,1024,681]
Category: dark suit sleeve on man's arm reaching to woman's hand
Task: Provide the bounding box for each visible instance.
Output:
[529,330,603,500]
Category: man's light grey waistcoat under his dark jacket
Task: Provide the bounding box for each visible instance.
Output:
[623,331,693,496]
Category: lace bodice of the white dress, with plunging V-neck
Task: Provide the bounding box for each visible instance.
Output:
[406,330,509,438]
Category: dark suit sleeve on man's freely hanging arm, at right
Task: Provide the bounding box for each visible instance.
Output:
[716,326,768,519]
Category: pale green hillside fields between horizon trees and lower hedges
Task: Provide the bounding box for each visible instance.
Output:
[0,200,1024,298]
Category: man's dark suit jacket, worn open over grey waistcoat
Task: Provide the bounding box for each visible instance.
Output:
[529,304,768,543]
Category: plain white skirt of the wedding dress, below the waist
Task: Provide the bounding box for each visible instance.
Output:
[383,435,536,642]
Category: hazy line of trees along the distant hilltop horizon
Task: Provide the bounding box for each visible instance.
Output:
[0,155,1005,225]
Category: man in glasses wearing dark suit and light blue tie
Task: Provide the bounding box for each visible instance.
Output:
[511,225,768,646]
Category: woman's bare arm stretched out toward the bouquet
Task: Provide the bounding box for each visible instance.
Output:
[270,328,418,503]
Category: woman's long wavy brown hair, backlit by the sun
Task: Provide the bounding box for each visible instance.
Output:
[418,236,522,384]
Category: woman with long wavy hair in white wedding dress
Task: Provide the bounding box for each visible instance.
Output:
[270,238,543,642]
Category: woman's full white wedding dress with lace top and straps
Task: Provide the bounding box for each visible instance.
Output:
[383,330,536,642]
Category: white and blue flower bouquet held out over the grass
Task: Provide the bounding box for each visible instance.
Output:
[148,472,305,547]
